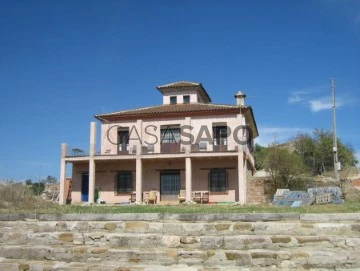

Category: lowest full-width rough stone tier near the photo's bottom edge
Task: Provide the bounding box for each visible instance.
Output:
[0,245,360,268]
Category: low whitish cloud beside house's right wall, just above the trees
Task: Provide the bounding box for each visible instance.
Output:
[255,126,312,146]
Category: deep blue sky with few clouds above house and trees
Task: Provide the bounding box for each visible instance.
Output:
[0,0,360,181]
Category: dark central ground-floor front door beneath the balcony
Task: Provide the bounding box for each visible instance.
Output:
[160,171,180,201]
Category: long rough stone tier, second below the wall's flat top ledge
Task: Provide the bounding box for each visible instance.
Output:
[0,231,360,253]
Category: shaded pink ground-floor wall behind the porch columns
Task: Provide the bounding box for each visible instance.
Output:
[72,157,242,203]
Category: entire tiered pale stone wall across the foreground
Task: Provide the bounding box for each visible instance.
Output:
[0,213,360,271]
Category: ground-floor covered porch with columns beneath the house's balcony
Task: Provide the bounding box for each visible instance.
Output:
[60,154,250,204]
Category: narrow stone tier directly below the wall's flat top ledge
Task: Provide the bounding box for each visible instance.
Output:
[0,222,360,237]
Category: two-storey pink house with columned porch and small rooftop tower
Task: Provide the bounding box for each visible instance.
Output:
[60,81,258,204]
